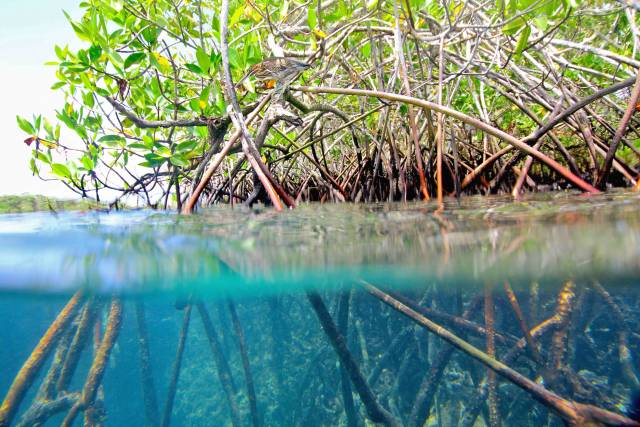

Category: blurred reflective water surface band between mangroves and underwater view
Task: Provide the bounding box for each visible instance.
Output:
[0,192,640,294]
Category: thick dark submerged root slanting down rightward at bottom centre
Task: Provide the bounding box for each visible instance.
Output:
[307,291,401,427]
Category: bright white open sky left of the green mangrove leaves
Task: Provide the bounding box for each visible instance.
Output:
[0,0,84,198]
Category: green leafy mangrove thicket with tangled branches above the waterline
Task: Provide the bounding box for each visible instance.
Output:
[13,0,640,206]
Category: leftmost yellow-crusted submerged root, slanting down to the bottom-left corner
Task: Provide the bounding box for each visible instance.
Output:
[0,289,85,427]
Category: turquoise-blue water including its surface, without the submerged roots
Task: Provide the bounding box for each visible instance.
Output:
[0,192,640,427]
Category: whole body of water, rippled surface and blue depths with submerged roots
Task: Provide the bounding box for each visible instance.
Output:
[0,191,640,427]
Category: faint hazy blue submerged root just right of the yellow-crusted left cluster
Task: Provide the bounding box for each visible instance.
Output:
[136,301,160,427]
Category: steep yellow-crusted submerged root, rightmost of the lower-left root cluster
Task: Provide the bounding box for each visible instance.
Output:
[62,296,123,427]
